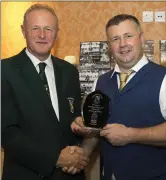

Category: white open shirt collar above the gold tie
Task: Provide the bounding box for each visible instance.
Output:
[111,55,149,78]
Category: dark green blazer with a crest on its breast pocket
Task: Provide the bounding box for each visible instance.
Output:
[1,49,84,180]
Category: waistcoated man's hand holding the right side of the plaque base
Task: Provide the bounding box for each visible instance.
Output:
[100,124,132,146]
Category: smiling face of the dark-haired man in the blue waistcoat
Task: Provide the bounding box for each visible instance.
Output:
[107,20,144,71]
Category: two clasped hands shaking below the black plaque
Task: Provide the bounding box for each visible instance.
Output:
[56,146,89,175]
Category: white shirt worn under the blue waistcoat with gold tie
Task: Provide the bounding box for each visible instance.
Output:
[92,55,166,120]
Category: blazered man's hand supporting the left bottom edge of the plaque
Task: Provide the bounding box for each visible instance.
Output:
[71,117,96,137]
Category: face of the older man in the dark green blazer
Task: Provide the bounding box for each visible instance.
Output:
[22,9,58,61]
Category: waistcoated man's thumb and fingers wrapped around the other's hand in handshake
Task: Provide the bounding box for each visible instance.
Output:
[62,146,89,175]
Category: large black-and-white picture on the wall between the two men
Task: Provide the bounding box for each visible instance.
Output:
[77,41,114,98]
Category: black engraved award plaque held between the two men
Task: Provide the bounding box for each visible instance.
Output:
[83,90,110,132]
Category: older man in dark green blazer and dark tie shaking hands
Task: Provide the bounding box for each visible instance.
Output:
[1,4,88,180]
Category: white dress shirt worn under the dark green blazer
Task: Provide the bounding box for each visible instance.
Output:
[25,49,59,121]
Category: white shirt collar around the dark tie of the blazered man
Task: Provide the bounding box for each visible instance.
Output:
[25,48,53,68]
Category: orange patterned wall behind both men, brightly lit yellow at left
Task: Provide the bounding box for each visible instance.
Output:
[2,2,166,63]
